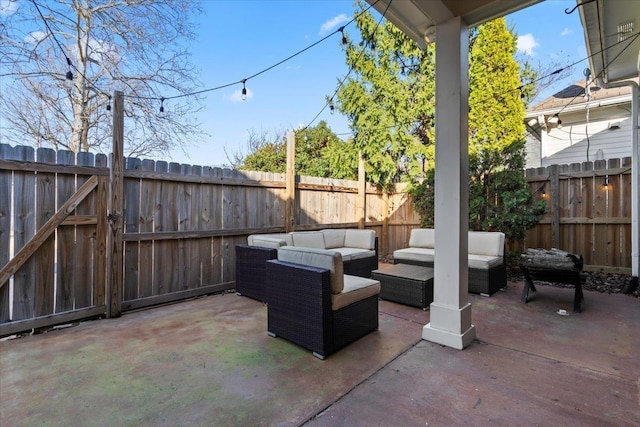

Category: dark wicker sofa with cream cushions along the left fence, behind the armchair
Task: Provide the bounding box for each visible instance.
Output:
[236,228,378,302]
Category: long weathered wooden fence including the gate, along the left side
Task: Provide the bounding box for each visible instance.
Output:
[0,144,419,336]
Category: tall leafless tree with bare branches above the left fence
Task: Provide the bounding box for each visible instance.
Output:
[0,0,203,156]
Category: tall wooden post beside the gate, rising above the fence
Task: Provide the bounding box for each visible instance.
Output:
[107,91,124,317]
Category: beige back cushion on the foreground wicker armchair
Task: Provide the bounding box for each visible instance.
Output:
[278,246,344,294]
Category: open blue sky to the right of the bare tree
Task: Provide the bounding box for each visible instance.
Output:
[172,0,587,165]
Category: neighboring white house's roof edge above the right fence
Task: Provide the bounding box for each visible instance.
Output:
[526,79,631,117]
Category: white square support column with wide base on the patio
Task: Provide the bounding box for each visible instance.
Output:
[422,17,476,350]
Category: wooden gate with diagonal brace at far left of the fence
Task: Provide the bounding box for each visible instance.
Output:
[0,144,109,336]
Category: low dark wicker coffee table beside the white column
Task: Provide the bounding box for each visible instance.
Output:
[371,264,433,310]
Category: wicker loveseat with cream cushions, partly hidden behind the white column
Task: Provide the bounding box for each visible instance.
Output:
[393,228,507,295]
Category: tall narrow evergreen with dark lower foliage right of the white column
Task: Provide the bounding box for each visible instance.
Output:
[412,18,544,244]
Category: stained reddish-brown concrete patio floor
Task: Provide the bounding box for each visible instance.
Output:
[0,274,640,427]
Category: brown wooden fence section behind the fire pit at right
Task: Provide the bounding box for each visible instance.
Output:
[525,157,632,272]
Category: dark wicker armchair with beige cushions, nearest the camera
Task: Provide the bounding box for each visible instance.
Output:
[266,246,380,359]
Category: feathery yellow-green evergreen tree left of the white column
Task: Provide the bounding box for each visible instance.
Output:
[331,0,435,188]
